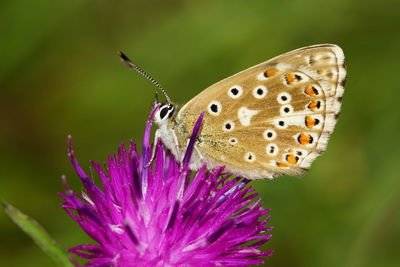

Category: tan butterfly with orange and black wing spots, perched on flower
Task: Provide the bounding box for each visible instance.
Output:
[118,44,346,180]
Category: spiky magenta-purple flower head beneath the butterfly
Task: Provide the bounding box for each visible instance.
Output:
[60,107,271,266]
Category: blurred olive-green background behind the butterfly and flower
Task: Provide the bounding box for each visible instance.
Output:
[0,0,400,267]
